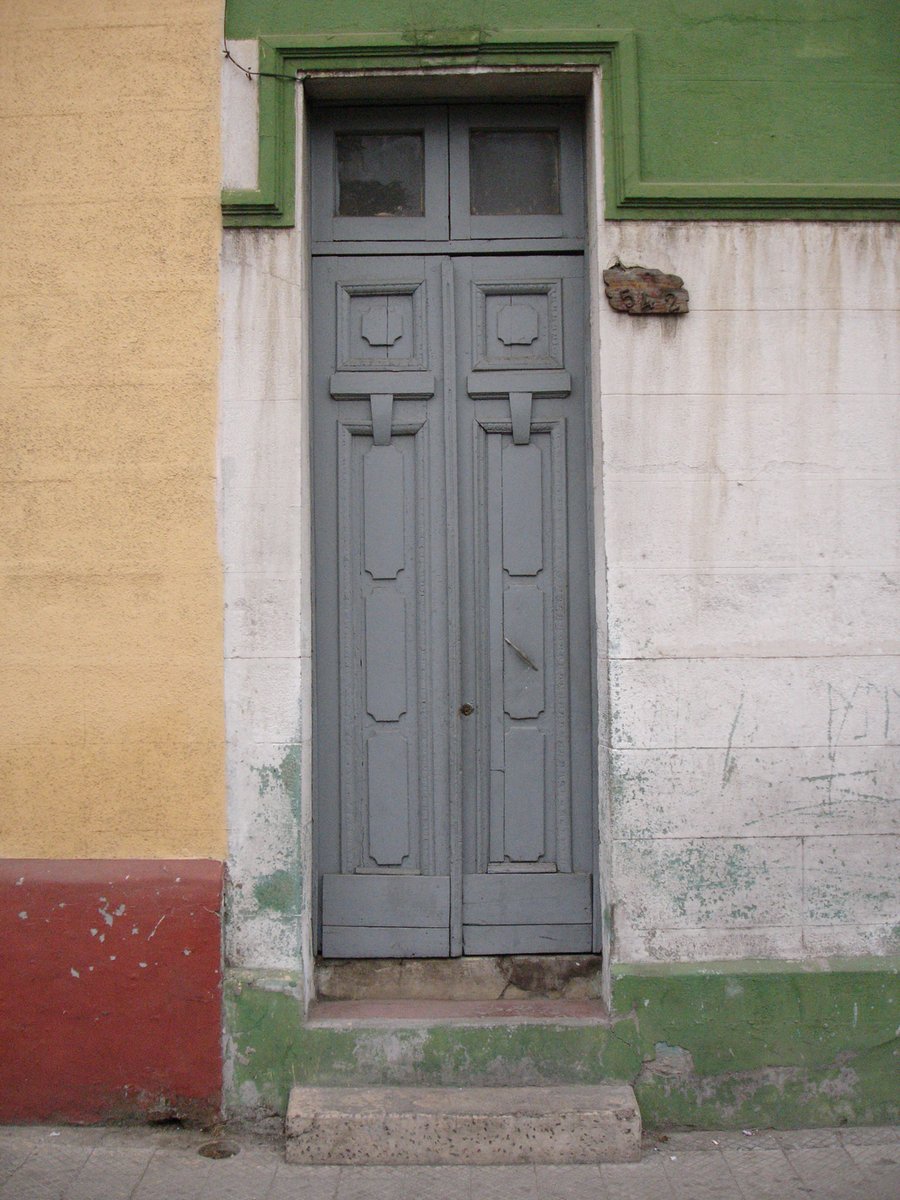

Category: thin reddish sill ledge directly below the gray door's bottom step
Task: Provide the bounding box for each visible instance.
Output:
[306,1000,608,1027]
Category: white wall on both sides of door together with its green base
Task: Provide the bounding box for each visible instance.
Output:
[221,51,898,1127]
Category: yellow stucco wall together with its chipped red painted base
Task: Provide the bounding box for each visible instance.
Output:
[0,0,226,1121]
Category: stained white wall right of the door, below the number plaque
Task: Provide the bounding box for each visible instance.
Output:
[599,222,900,961]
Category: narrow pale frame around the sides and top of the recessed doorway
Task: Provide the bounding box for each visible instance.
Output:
[295,66,611,1007]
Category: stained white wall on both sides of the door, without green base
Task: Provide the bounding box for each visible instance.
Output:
[221,58,900,971]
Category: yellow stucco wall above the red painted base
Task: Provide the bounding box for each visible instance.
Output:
[0,0,224,858]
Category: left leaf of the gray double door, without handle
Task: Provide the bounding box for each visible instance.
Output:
[313,258,450,956]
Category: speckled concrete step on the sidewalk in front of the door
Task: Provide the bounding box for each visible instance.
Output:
[284,1084,641,1166]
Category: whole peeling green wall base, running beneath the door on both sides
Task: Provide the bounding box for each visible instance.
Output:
[226,959,900,1129]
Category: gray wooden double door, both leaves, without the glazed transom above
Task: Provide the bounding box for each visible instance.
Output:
[313,254,594,958]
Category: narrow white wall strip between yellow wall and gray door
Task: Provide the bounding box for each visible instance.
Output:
[220,70,312,988]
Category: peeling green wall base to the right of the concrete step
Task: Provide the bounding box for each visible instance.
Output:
[613,959,899,1128]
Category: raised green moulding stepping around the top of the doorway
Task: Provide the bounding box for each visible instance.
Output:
[222,29,900,227]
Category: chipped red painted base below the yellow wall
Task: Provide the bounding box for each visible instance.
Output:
[0,859,223,1122]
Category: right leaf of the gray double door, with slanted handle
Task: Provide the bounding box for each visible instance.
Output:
[455,256,593,954]
